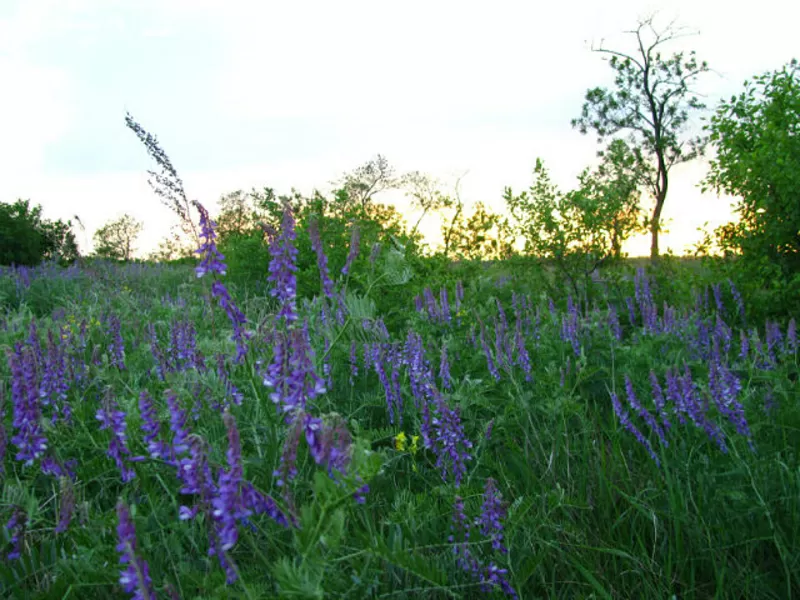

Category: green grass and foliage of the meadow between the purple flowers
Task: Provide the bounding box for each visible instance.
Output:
[0,255,800,599]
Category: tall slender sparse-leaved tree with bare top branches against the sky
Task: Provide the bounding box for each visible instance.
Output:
[572,17,708,259]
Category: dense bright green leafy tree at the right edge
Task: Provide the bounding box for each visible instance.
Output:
[703,60,800,310]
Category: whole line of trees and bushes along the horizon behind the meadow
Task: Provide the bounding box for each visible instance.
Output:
[0,20,800,310]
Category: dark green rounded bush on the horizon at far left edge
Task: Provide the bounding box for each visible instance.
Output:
[0,200,78,266]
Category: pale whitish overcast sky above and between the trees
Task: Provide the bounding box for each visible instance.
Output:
[0,0,800,254]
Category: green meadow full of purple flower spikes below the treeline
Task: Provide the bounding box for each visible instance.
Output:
[0,210,800,600]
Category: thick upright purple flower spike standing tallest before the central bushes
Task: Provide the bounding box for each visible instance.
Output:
[267,203,297,323]
